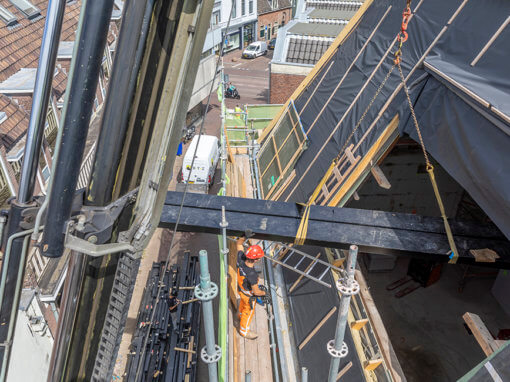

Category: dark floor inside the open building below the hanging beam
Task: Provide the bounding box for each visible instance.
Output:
[363,258,510,382]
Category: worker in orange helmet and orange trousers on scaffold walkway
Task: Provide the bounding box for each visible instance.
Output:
[237,238,268,340]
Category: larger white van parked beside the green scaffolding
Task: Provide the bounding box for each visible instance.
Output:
[181,135,220,185]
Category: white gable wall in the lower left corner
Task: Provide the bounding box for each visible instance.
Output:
[8,292,53,382]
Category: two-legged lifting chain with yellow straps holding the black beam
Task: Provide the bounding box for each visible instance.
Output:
[294,0,459,264]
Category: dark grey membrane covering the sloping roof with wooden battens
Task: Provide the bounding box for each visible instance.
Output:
[279,0,510,238]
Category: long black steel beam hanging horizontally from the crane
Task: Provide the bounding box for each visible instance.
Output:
[159,192,510,269]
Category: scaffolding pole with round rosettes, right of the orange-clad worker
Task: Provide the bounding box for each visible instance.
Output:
[327,245,359,382]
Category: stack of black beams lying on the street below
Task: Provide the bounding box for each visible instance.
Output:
[126,253,201,382]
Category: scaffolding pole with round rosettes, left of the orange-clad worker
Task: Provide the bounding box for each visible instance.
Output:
[195,250,221,382]
